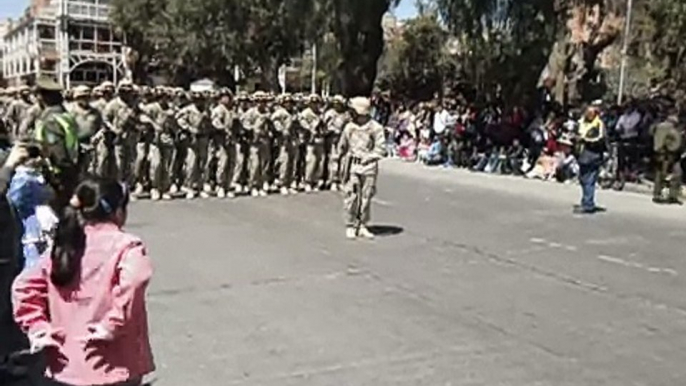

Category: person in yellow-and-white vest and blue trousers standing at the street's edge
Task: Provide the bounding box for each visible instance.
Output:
[574,107,605,214]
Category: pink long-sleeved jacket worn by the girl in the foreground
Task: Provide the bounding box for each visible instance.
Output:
[12,224,154,385]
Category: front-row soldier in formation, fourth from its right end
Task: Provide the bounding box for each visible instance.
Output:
[241,91,271,197]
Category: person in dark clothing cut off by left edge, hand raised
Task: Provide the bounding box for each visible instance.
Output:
[0,132,31,386]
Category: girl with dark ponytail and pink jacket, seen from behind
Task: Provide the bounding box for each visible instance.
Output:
[12,180,154,386]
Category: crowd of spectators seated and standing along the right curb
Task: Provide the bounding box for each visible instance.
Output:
[376,93,680,189]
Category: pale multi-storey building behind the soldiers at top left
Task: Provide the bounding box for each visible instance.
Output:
[2,0,125,88]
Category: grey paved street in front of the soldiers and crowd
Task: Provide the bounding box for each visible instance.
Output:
[129,161,686,386]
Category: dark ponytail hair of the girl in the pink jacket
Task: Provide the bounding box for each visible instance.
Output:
[50,179,129,287]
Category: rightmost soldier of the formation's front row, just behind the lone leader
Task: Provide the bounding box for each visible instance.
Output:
[324,95,350,191]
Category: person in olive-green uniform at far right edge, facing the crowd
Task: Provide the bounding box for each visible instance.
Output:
[653,108,684,205]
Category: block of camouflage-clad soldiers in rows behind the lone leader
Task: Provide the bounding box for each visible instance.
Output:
[0,80,370,205]
